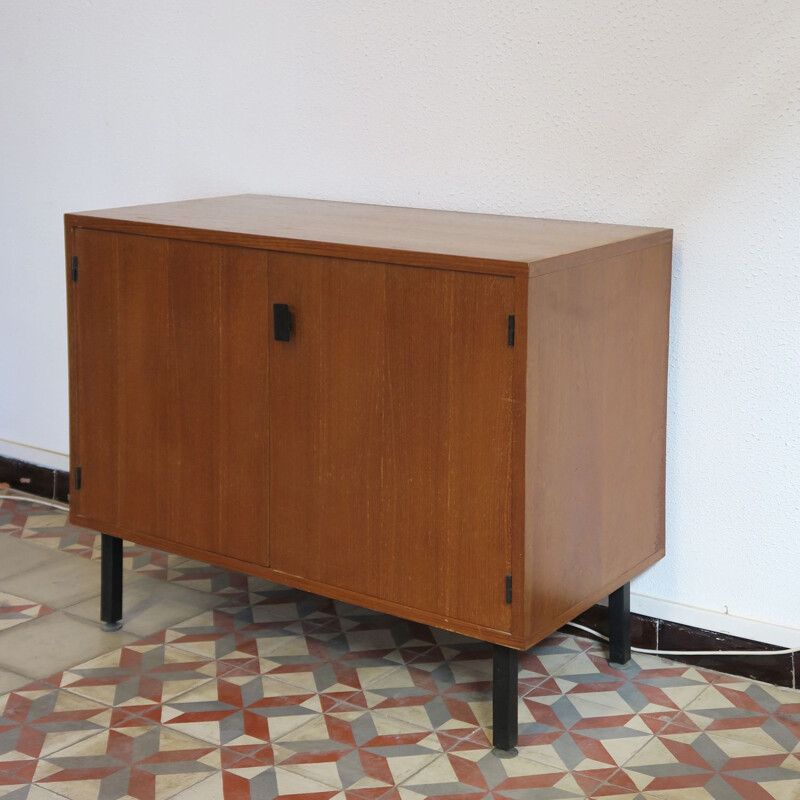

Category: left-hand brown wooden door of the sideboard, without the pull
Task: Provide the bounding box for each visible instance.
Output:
[70,229,269,565]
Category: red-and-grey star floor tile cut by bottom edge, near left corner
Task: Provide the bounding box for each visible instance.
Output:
[34,725,220,800]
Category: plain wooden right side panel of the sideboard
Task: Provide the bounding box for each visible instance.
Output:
[526,245,671,643]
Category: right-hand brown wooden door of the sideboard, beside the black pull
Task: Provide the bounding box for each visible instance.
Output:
[270,254,513,629]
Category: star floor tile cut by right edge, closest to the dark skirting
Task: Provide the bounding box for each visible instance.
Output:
[675,675,800,753]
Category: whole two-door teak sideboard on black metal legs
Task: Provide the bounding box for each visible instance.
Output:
[65,195,672,749]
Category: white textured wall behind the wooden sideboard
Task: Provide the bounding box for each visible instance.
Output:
[0,0,800,640]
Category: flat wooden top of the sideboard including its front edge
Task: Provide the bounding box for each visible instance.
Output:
[67,194,672,268]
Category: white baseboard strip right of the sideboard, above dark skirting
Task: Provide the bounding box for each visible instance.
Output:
[631,592,800,647]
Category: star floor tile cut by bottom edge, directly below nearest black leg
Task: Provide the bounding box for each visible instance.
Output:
[398,750,600,800]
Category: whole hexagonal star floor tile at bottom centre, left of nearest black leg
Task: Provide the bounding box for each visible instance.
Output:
[273,703,446,796]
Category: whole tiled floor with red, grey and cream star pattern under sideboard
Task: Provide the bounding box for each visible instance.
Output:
[0,490,800,800]
